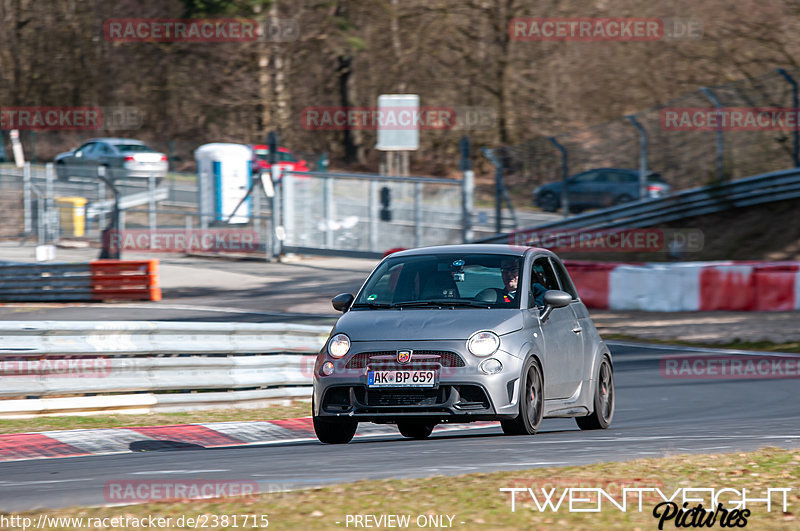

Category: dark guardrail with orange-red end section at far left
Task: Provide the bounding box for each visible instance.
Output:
[0,260,161,302]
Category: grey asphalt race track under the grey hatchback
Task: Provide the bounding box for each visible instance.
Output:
[0,343,800,511]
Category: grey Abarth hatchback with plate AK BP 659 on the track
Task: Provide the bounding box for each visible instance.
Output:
[313,245,614,444]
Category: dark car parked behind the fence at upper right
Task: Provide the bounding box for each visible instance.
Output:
[533,168,670,212]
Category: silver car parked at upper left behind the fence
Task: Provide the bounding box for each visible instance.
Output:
[55,138,168,180]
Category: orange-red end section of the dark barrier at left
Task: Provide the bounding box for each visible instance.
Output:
[89,260,161,301]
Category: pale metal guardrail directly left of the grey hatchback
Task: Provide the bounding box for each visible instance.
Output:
[0,321,330,418]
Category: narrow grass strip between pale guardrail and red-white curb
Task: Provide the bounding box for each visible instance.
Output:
[0,401,311,433]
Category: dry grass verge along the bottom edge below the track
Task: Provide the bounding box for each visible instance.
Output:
[4,448,800,530]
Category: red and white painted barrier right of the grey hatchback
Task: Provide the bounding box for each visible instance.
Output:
[566,261,800,312]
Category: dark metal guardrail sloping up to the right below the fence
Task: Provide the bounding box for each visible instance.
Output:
[480,168,800,243]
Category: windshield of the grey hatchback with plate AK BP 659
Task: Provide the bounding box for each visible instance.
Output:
[353,253,522,309]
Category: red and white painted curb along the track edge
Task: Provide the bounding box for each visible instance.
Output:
[0,417,498,462]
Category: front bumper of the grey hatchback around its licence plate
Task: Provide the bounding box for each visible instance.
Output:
[314,341,522,423]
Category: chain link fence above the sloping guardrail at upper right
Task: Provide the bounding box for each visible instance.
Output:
[494,69,800,213]
